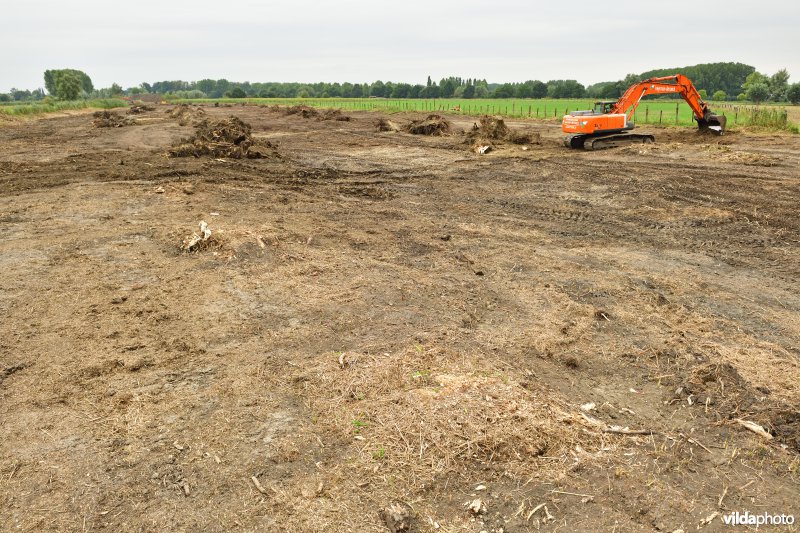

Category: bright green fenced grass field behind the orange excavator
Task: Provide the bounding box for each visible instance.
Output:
[174,98,796,129]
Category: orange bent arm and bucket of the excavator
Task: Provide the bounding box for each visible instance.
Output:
[612,74,725,132]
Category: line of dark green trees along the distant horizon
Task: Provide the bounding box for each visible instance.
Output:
[0,63,800,104]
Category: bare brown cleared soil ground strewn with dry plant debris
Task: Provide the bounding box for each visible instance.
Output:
[0,106,800,532]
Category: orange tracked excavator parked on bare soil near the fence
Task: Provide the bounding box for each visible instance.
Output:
[561,74,725,150]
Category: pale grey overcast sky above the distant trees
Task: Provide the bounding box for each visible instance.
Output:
[0,0,800,92]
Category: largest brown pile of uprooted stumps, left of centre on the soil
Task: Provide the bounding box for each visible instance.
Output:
[169,116,275,159]
